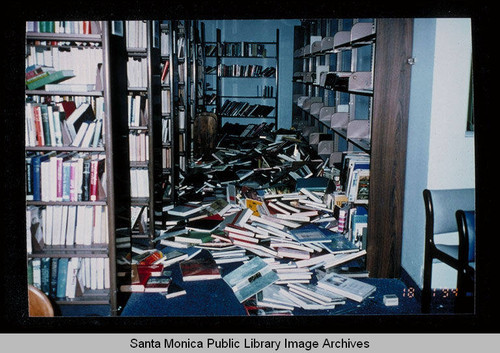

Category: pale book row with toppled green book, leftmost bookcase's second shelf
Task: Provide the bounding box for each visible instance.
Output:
[25,44,103,92]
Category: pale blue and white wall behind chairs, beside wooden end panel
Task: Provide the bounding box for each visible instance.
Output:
[401,18,475,288]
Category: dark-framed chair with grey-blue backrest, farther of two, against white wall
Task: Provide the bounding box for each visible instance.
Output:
[422,189,475,313]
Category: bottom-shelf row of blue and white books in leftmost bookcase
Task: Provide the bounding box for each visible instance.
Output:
[28,257,110,300]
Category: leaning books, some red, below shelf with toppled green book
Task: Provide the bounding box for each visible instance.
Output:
[25,97,104,147]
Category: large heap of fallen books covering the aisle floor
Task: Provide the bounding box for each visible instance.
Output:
[121,124,375,315]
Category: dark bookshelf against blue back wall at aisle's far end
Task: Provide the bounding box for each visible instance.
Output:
[204,29,279,128]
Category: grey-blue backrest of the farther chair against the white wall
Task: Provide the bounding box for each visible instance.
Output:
[424,189,475,234]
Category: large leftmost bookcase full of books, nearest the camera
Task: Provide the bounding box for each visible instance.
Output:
[25,21,129,316]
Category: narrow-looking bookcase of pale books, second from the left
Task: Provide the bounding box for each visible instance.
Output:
[125,21,161,245]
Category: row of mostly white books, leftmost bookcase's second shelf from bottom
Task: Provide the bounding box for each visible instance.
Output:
[26,205,108,253]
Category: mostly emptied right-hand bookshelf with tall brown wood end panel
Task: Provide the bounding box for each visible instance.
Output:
[293,19,412,277]
